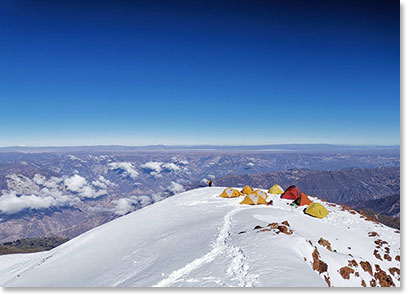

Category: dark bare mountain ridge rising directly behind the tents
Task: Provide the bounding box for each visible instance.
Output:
[214,167,400,216]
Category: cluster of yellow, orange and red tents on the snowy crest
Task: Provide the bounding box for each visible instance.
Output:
[219,185,328,218]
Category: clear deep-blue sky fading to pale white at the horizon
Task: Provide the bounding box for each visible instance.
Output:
[0,0,400,146]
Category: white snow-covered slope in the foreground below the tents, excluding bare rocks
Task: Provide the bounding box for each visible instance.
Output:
[0,187,400,287]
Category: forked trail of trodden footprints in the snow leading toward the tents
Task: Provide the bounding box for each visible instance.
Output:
[153,208,255,287]
